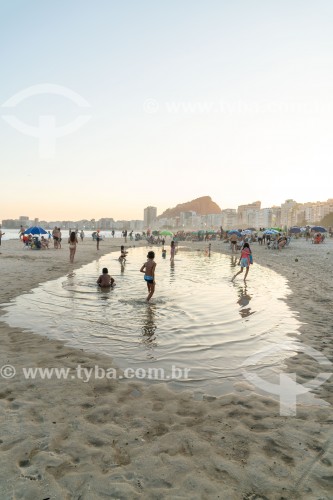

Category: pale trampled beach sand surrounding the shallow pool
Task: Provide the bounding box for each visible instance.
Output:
[0,239,333,500]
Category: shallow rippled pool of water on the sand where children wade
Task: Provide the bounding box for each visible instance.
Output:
[2,248,299,393]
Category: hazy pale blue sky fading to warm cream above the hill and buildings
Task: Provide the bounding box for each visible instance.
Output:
[0,0,333,219]
